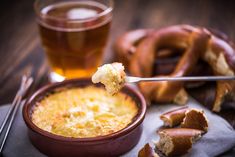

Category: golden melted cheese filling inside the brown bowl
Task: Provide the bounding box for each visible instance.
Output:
[32,86,138,138]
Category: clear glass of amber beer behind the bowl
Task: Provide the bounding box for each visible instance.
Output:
[34,0,113,82]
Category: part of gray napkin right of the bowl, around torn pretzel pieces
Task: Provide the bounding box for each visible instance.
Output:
[123,98,235,157]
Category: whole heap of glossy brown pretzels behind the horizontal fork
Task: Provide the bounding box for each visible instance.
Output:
[115,25,235,112]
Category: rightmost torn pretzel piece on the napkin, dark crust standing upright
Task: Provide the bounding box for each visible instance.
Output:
[181,109,208,132]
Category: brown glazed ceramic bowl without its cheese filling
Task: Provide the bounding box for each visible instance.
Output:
[23,79,146,157]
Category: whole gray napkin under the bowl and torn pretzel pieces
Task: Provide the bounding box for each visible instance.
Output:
[0,99,235,157]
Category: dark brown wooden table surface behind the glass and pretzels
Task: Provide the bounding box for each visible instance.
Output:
[0,0,235,155]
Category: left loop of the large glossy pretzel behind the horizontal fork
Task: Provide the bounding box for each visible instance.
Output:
[129,27,209,104]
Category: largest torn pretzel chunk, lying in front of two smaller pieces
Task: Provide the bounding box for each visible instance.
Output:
[157,128,202,156]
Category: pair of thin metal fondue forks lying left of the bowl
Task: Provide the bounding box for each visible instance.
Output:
[0,75,33,155]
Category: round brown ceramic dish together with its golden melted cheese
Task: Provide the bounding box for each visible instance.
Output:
[23,78,146,157]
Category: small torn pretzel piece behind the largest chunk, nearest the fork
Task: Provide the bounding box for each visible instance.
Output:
[160,106,189,127]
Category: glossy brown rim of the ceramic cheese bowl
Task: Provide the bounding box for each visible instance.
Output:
[22,78,147,143]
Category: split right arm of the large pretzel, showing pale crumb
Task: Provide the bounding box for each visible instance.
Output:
[202,32,235,112]
